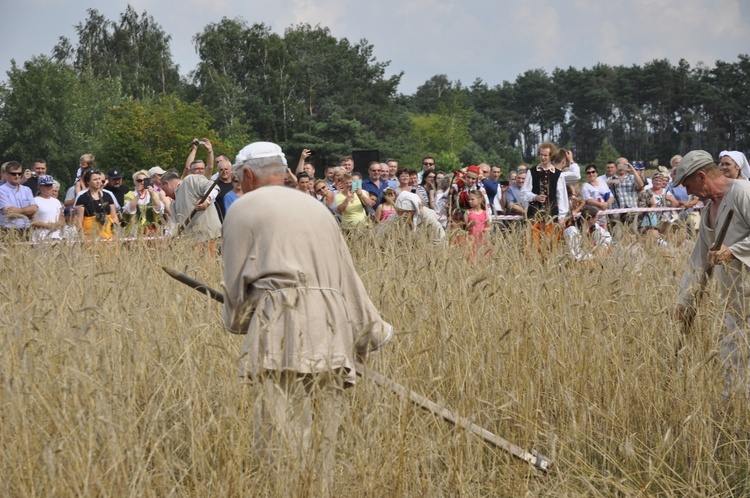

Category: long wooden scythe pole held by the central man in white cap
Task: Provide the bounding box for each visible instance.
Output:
[162,266,552,473]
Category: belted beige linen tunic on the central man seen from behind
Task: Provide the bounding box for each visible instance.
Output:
[222,186,392,383]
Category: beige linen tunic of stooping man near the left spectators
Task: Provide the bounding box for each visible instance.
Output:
[169,175,221,241]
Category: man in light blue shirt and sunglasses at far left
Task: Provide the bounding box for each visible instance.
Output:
[0,161,38,237]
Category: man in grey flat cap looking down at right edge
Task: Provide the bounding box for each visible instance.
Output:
[674,150,750,396]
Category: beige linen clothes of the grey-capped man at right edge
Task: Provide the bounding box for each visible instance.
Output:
[677,180,750,381]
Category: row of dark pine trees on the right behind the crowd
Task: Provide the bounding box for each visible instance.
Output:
[462,55,750,164]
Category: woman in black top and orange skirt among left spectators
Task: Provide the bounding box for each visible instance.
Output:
[75,168,119,239]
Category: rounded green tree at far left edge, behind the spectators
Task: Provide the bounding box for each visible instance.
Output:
[0,56,120,183]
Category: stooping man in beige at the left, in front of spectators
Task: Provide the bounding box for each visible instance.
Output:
[161,170,221,242]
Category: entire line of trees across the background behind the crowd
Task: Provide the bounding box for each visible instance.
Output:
[0,6,750,187]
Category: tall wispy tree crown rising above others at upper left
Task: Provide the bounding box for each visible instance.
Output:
[52,5,180,98]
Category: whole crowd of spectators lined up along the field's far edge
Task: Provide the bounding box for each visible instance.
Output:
[0,138,750,260]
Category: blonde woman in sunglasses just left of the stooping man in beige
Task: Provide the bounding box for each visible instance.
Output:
[122,169,164,235]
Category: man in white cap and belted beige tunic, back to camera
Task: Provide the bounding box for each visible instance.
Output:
[221,142,392,496]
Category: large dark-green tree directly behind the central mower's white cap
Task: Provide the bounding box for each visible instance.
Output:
[192,18,405,164]
